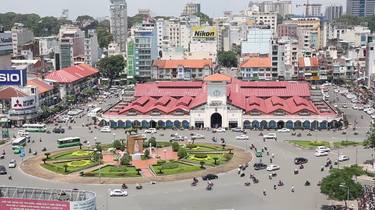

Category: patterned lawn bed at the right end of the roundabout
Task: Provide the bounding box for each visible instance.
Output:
[186,153,233,166]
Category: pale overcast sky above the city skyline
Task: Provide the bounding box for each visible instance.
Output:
[0,0,346,19]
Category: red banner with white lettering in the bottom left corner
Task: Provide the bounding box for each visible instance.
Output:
[0,198,70,210]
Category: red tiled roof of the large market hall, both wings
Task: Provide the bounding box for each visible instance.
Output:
[106,74,335,115]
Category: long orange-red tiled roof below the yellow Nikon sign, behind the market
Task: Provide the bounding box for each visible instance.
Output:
[153,59,213,69]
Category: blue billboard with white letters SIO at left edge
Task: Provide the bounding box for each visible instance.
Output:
[0,69,27,86]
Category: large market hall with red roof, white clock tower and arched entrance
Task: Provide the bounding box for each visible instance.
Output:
[98,74,342,129]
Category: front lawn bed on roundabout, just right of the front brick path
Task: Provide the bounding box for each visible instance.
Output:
[151,161,202,175]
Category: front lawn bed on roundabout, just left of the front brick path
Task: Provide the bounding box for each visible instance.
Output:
[90,165,140,177]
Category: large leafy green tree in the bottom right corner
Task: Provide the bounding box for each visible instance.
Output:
[320,166,362,201]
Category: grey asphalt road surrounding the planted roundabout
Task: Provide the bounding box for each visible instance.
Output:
[0,85,372,210]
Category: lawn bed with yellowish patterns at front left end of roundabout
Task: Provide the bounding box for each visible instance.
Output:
[41,160,98,174]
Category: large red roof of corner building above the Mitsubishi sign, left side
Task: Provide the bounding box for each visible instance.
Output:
[46,64,99,83]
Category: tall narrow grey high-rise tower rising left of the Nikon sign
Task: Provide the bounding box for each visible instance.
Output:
[110,0,128,52]
